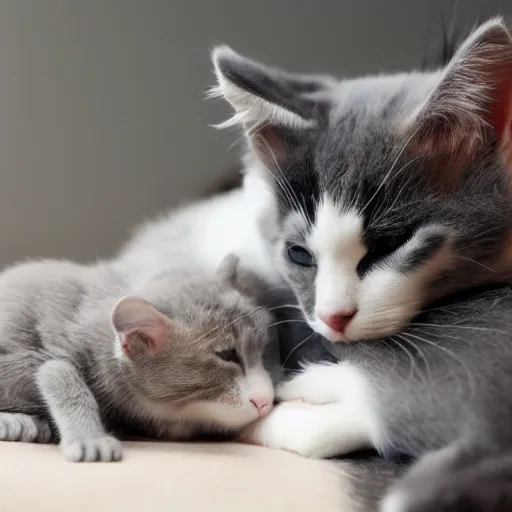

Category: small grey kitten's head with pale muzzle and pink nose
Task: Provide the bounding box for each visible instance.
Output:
[112,255,274,429]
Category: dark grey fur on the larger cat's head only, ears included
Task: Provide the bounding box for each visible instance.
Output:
[213,20,512,336]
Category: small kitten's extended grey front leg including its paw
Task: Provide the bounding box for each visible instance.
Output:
[37,360,122,462]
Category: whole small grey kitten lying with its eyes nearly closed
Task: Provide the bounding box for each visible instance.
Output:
[0,255,274,461]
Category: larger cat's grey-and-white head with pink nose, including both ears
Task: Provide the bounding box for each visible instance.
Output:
[213,19,512,341]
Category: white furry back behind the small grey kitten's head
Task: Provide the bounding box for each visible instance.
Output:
[120,182,282,290]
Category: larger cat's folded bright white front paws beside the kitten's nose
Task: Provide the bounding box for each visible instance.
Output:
[241,363,379,458]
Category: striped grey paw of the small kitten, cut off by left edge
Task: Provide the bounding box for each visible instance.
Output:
[0,412,52,443]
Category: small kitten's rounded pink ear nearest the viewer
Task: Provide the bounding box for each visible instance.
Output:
[112,297,171,358]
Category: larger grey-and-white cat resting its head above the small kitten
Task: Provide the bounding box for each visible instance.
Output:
[213,18,512,512]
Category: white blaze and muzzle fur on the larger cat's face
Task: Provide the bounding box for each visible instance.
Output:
[295,197,451,342]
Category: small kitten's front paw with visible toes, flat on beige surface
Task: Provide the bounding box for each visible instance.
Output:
[60,435,123,462]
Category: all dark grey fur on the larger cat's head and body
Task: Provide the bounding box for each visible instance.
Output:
[214,16,512,511]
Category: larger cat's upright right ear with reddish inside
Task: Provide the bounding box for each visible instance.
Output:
[409,18,512,170]
